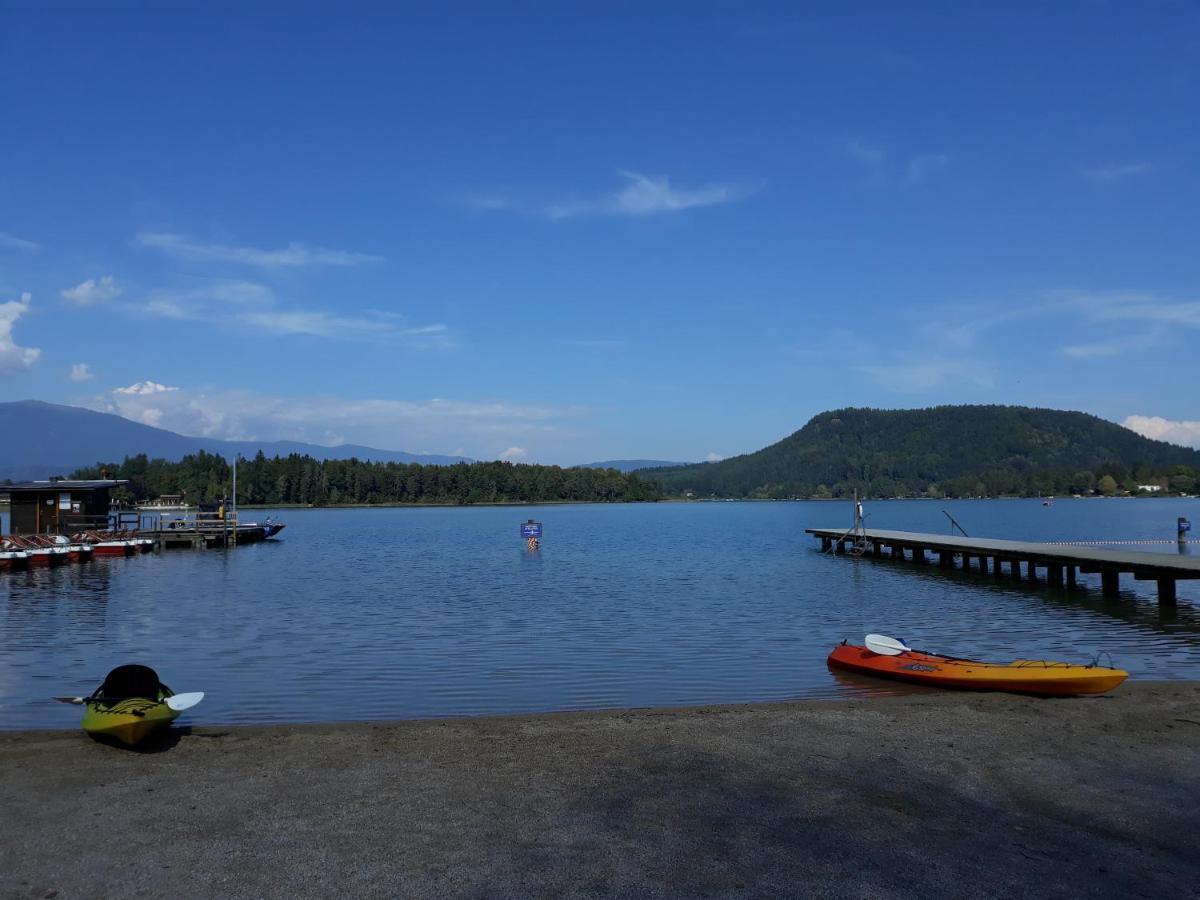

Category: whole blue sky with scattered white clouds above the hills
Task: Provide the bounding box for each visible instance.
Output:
[0,0,1200,464]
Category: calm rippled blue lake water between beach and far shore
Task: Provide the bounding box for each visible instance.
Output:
[0,499,1200,728]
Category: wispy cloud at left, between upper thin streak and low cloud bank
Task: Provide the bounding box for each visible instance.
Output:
[136,281,452,349]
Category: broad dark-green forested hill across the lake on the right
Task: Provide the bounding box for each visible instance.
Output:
[641,406,1200,497]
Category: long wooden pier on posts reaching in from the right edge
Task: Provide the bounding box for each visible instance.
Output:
[804,528,1200,606]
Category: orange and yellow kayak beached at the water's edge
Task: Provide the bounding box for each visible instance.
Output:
[829,643,1129,697]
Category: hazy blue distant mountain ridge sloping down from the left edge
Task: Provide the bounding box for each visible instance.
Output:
[0,400,466,481]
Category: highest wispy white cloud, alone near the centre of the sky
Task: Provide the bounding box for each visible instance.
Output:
[458,170,762,221]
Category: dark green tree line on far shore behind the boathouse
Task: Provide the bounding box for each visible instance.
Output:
[71,451,661,506]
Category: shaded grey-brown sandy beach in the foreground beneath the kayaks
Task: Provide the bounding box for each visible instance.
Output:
[0,683,1200,898]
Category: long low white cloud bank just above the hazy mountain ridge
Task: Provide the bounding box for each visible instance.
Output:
[84,388,586,458]
